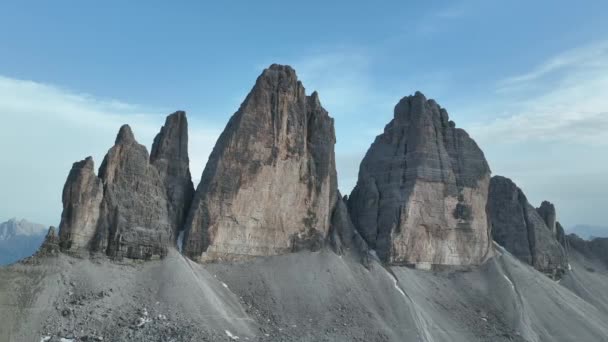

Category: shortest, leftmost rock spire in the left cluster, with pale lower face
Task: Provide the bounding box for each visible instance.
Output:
[59,157,103,251]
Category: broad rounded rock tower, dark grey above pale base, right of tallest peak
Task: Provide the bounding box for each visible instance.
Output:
[348,92,491,268]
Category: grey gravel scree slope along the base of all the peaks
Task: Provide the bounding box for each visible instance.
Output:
[0,246,608,342]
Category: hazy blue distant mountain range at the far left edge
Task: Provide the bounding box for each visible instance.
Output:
[0,218,47,265]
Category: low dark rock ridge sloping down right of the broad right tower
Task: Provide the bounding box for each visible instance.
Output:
[488,176,568,278]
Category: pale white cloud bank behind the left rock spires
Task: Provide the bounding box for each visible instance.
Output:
[0,76,219,224]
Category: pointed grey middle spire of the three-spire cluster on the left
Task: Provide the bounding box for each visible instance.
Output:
[94,125,172,259]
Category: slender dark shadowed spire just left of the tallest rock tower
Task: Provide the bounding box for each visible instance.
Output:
[150,111,194,237]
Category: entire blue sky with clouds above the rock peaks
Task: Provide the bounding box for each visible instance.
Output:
[0,0,608,227]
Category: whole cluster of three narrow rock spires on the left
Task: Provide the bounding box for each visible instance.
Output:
[59,112,193,259]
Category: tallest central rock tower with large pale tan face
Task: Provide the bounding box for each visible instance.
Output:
[184,65,337,260]
